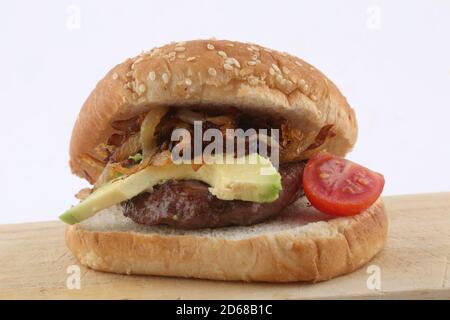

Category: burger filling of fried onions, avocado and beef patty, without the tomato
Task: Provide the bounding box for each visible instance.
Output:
[61,107,333,229]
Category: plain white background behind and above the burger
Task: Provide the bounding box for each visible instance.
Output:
[0,0,450,223]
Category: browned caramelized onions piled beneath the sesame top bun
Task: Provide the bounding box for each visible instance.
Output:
[94,107,334,186]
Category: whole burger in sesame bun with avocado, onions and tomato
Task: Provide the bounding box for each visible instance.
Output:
[60,39,387,282]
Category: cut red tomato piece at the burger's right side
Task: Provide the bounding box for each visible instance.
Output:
[303,151,384,216]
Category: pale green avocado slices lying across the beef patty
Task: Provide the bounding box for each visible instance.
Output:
[59,154,281,224]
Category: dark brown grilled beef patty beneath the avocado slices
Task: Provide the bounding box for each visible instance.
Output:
[121,162,305,229]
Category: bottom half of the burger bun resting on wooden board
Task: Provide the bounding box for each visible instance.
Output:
[66,199,388,282]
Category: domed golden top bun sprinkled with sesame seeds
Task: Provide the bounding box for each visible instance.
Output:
[70,40,357,182]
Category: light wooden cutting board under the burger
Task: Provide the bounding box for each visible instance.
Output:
[0,193,450,299]
